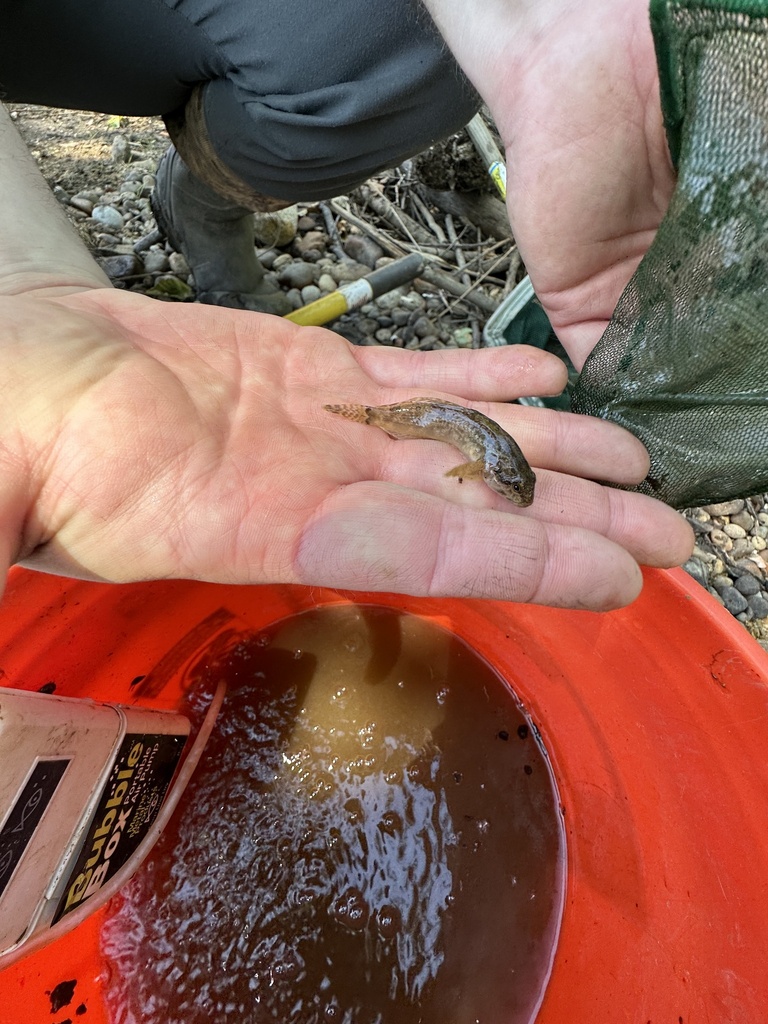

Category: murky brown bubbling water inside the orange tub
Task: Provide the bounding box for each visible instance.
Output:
[103,605,563,1024]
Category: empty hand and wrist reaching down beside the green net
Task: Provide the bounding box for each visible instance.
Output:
[425,0,675,369]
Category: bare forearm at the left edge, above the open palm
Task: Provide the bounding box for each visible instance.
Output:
[0,104,110,295]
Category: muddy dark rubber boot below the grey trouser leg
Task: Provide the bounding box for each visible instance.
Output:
[152,145,293,316]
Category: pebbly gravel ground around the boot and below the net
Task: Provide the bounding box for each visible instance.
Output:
[14,106,768,650]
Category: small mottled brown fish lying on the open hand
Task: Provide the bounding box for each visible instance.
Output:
[323,398,536,508]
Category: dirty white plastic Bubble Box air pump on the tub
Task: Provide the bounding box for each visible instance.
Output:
[0,689,207,967]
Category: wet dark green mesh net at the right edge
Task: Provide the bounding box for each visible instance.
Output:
[573,0,768,508]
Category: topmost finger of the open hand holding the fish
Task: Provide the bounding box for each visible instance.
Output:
[353,337,568,401]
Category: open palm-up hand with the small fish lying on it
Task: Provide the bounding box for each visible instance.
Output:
[0,289,691,609]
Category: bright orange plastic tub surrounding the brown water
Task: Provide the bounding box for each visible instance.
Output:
[0,570,768,1024]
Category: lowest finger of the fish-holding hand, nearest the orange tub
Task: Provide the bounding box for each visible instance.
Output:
[294,481,642,610]
